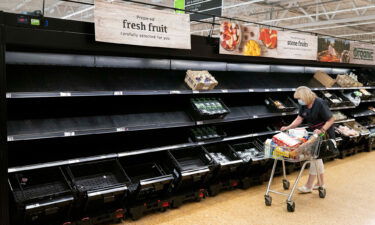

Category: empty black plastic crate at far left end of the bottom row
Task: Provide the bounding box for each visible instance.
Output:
[9,167,74,225]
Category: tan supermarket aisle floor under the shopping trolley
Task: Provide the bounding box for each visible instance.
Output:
[124,152,375,225]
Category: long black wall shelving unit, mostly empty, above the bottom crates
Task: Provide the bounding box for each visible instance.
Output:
[0,13,375,225]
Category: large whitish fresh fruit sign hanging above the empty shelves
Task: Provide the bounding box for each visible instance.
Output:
[95,0,191,49]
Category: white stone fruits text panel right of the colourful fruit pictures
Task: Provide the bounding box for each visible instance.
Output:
[277,32,318,60]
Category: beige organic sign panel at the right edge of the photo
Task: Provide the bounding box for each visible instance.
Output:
[350,41,375,64]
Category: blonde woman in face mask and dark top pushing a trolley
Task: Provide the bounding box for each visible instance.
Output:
[281,86,335,193]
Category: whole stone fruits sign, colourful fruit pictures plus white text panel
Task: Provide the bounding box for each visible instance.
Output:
[220,21,317,60]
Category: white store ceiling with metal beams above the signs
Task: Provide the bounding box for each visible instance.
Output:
[0,0,375,43]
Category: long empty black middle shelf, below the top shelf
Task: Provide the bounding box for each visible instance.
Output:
[8,105,297,142]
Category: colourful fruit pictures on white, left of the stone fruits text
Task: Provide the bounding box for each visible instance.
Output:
[220,21,278,57]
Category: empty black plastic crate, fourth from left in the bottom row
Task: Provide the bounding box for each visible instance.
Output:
[168,147,217,191]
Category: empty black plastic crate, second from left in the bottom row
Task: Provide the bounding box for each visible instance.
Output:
[66,159,130,220]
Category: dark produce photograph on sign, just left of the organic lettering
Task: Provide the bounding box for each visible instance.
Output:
[318,37,350,63]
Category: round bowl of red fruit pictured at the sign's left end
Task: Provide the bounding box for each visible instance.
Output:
[220,22,241,51]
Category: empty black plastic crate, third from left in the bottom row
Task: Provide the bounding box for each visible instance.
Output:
[119,152,174,201]
